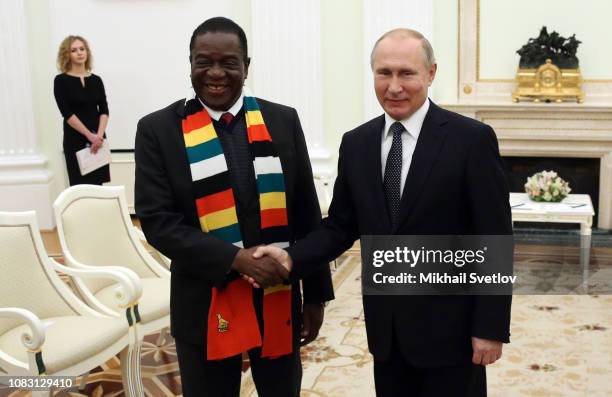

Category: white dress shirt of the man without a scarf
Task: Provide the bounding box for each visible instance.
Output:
[380,99,429,198]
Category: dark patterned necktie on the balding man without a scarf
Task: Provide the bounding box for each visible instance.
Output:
[384,121,405,228]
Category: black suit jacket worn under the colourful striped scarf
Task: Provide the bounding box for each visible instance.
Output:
[135,99,334,344]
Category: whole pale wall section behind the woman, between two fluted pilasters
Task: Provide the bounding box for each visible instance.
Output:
[25,0,251,204]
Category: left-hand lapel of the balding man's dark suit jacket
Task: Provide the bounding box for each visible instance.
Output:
[362,115,391,231]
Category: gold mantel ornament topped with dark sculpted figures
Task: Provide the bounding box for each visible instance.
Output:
[512,26,584,103]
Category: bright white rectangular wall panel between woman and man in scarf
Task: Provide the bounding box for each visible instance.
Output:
[44,0,241,149]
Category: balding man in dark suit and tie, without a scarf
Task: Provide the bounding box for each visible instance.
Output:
[255,29,512,397]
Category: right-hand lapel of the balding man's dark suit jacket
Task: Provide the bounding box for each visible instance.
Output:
[394,102,446,233]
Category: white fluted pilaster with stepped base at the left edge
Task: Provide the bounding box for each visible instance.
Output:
[0,0,55,229]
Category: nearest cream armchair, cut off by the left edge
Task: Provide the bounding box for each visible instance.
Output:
[0,211,142,396]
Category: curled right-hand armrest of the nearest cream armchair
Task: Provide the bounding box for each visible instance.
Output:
[50,258,142,307]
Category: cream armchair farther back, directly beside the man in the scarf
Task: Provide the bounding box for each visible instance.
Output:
[53,185,170,337]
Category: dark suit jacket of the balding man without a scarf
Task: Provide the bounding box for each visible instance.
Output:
[288,103,512,367]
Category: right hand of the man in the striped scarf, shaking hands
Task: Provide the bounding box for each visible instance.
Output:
[232,248,289,288]
